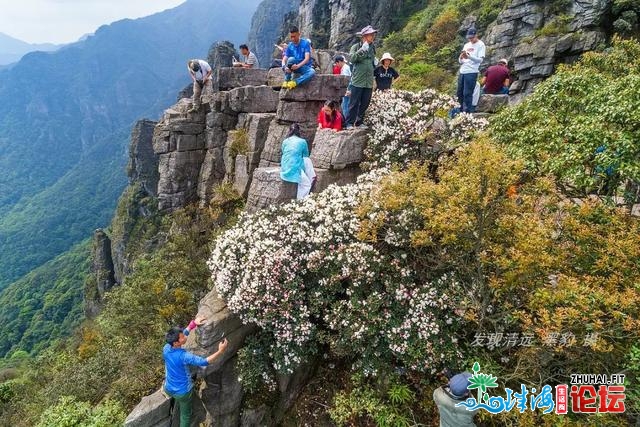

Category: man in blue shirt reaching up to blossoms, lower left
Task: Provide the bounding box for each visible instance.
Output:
[162,319,228,427]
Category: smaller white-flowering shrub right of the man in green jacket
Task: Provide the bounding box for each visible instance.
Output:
[365,89,488,169]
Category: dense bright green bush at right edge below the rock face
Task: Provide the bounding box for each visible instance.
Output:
[492,39,640,201]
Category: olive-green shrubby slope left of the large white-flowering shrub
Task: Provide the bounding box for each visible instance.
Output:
[0,198,238,427]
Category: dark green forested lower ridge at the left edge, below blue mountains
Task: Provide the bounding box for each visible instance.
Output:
[0,241,90,357]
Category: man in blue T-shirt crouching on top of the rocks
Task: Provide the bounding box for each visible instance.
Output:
[282,27,316,89]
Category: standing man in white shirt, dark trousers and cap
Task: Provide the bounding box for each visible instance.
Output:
[457,27,486,113]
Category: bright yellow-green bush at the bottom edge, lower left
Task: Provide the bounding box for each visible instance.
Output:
[36,397,126,427]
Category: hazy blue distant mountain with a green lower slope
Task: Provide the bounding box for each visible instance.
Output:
[0,0,259,290]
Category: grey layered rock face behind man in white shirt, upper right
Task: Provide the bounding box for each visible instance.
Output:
[484,0,612,102]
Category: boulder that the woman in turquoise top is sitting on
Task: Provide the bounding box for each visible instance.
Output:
[246,167,298,213]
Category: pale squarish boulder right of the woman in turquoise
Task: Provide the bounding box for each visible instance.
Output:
[311,129,369,169]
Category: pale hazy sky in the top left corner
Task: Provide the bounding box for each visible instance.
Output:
[0,0,185,43]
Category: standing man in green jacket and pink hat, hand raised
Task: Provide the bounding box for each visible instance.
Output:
[347,25,378,129]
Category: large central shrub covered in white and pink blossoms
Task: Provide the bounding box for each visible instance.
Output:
[209,170,464,376]
